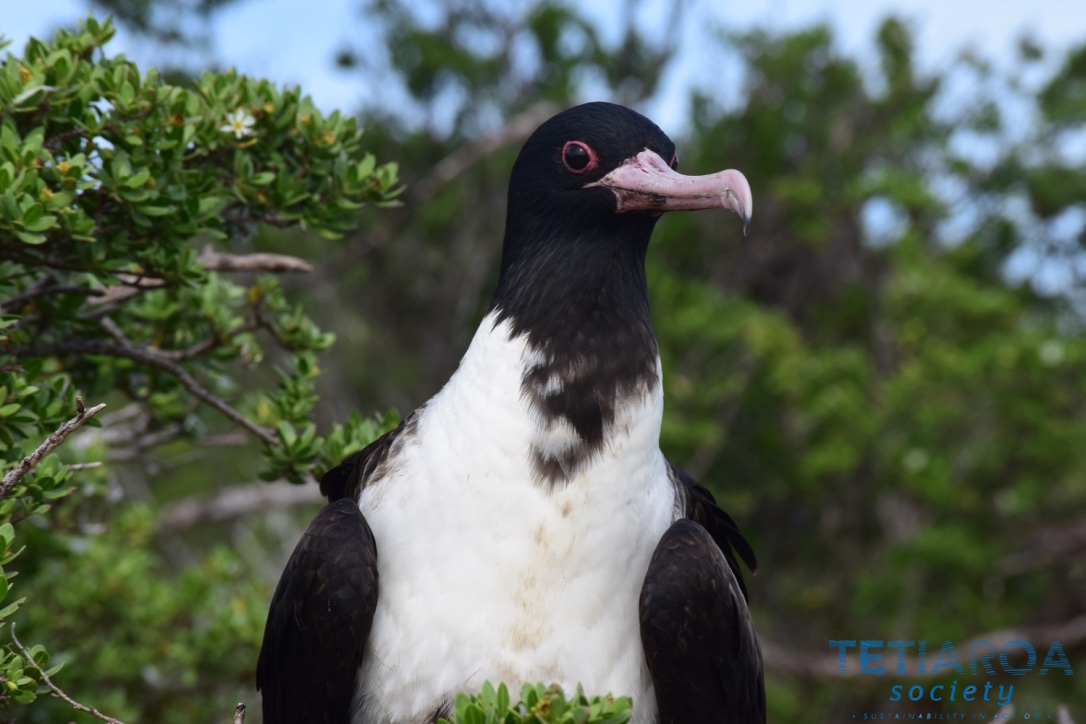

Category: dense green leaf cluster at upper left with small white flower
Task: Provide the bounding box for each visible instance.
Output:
[0,18,395,250]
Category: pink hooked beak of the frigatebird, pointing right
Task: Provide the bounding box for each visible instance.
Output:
[585,149,754,236]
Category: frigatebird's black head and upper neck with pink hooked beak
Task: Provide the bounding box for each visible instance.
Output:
[491,103,753,347]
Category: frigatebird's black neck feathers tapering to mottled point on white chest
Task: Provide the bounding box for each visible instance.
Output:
[491,206,659,485]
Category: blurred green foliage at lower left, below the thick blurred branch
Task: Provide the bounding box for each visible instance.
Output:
[18,505,267,724]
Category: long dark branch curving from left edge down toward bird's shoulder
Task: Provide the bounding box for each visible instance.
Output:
[0,338,279,446]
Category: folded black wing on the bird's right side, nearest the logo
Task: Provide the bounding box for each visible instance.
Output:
[641,467,766,724]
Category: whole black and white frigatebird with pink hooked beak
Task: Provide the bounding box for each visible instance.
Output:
[256,103,766,724]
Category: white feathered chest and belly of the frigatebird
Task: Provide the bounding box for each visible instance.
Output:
[355,319,674,722]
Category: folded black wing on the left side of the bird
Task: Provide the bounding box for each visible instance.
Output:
[256,499,378,724]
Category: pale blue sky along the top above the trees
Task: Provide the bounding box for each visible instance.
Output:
[6,0,1086,128]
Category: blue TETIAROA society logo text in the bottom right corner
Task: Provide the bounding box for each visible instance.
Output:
[830,639,1074,708]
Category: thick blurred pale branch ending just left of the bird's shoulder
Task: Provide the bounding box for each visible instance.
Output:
[159,483,324,531]
